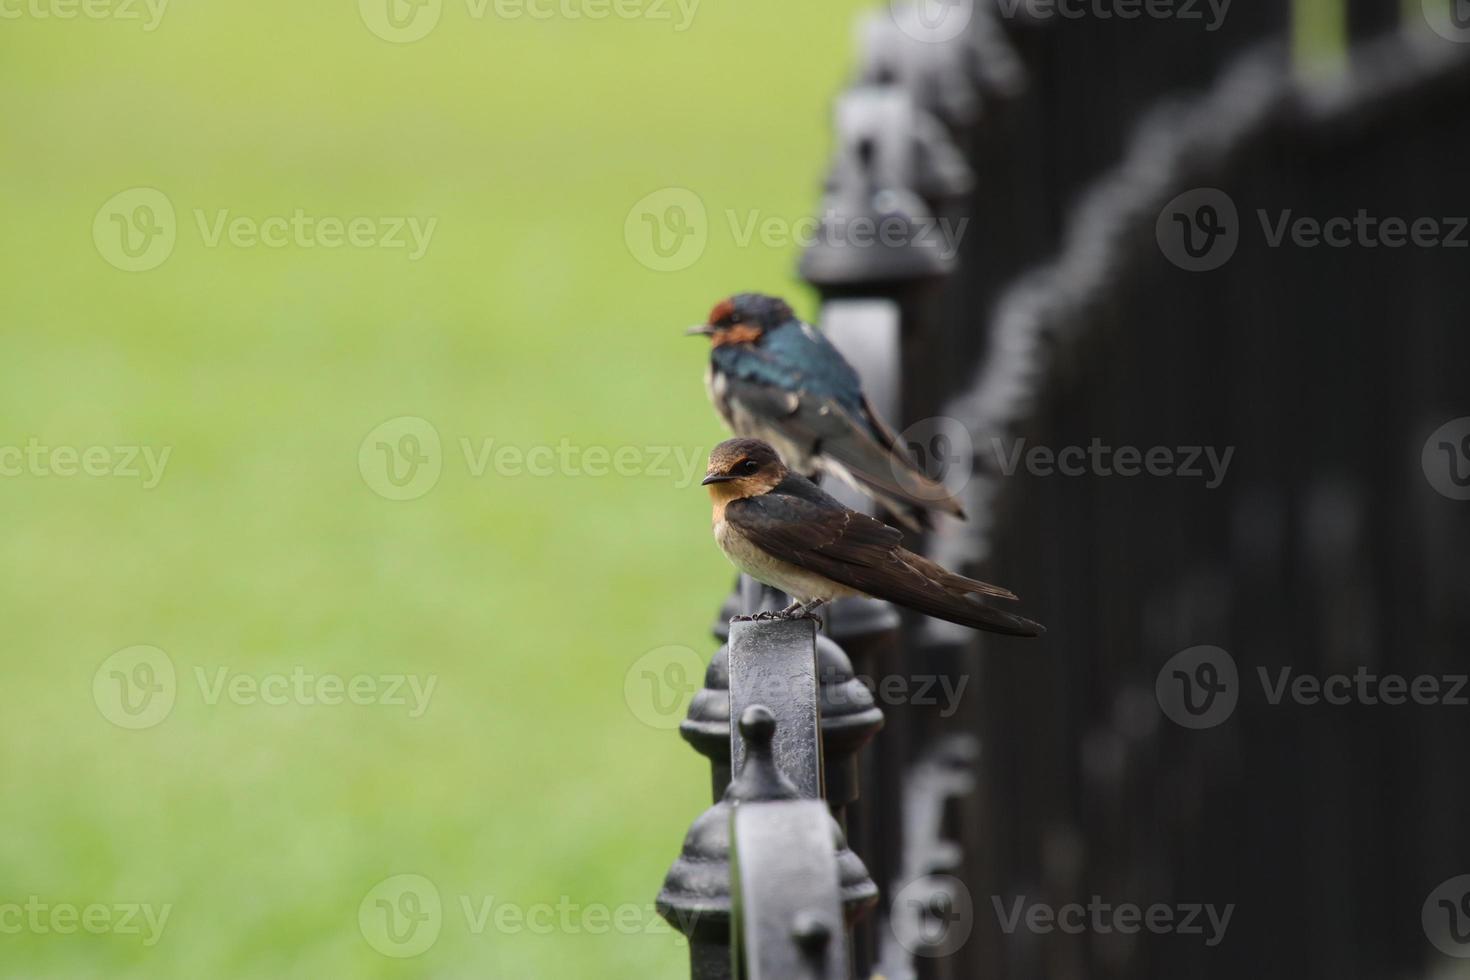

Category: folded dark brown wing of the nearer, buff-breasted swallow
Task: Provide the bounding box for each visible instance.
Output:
[725,487,1042,636]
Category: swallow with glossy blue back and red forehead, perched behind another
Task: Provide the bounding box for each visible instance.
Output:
[685,292,964,530]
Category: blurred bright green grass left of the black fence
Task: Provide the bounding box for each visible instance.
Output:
[0,0,864,979]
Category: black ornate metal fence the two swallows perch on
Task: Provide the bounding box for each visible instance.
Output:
[660,0,1470,980]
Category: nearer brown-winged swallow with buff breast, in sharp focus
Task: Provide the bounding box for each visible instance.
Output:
[701,439,1045,636]
